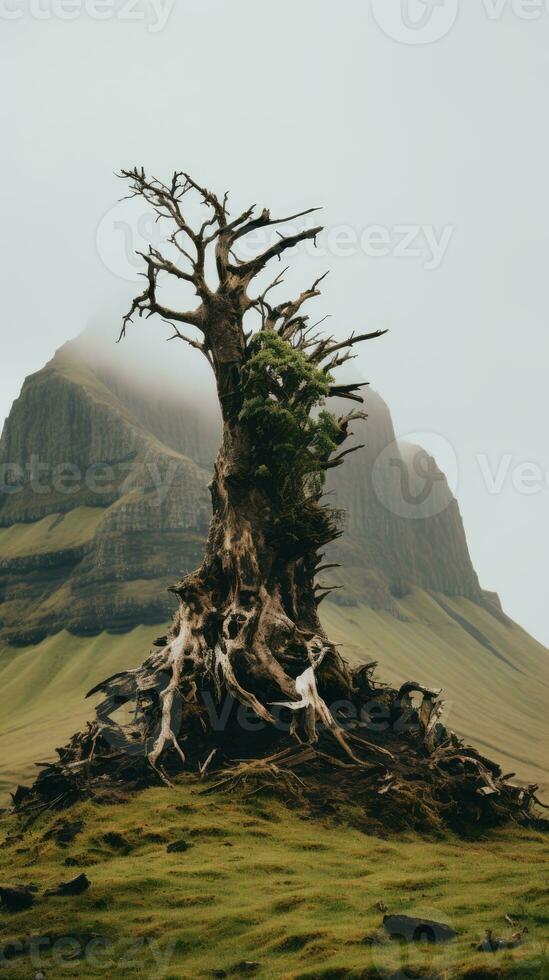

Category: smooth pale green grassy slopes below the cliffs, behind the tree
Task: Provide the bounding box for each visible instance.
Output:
[0,589,549,800]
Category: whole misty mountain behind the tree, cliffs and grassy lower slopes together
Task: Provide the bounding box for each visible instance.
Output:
[0,335,549,800]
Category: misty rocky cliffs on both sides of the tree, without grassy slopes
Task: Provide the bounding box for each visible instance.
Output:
[0,341,483,643]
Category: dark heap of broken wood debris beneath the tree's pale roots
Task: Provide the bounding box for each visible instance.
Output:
[13,664,542,831]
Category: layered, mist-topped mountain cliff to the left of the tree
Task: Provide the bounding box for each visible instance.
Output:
[0,343,215,644]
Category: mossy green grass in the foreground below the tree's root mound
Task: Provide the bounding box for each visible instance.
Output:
[0,779,549,980]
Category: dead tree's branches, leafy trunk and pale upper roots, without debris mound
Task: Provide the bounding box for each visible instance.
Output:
[93,169,382,780]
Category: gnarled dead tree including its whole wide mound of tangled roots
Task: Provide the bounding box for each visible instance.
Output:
[14,169,537,825]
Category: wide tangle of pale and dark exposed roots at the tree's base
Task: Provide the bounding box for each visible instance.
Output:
[14,626,548,830]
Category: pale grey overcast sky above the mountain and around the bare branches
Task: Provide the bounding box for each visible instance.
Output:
[0,0,549,645]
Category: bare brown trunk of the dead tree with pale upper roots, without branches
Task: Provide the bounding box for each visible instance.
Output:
[113,284,358,772]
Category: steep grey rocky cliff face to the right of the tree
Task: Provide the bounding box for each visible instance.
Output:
[332,391,481,608]
